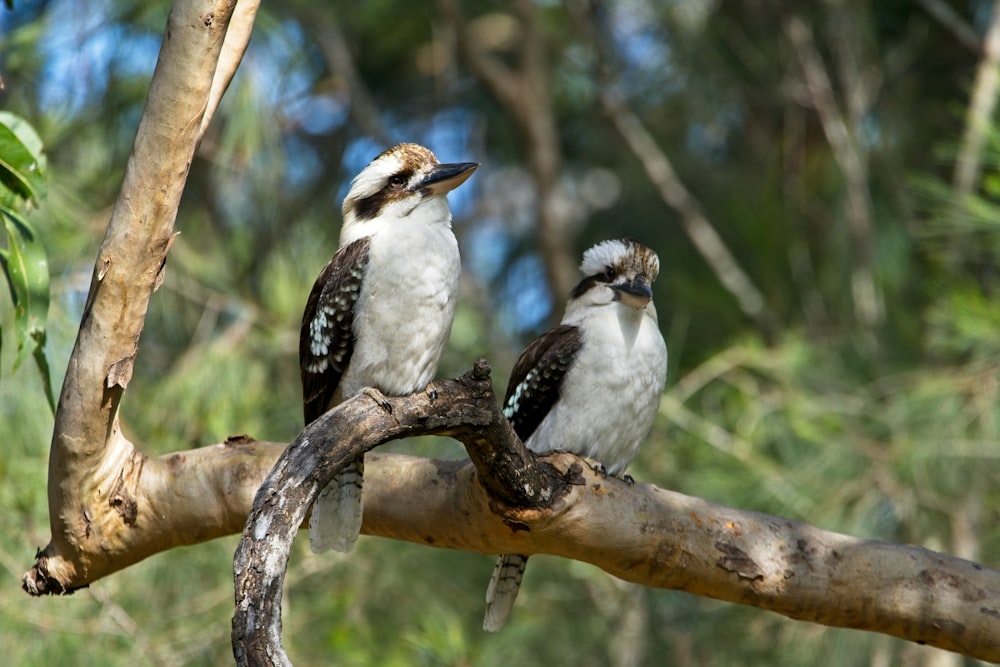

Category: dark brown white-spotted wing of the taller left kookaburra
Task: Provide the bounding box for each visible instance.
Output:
[299,237,369,424]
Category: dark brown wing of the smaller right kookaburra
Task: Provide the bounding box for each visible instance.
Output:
[503,325,583,442]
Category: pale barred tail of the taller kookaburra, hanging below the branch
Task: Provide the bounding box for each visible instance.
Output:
[309,455,365,554]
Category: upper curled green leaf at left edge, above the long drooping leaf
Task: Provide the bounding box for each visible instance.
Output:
[0,111,46,208]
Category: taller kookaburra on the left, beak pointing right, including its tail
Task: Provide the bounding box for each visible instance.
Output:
[299,143,479,553]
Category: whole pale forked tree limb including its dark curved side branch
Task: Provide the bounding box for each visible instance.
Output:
[23,0,1000,664]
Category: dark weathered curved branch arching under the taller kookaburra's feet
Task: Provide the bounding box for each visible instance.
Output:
[232,361,569,665]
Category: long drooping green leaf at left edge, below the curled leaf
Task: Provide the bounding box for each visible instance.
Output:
[0,207,51,378]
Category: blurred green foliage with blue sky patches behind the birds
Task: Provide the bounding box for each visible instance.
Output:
[0,0,1000,666]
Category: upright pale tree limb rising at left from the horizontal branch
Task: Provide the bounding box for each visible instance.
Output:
[23,0,244,593]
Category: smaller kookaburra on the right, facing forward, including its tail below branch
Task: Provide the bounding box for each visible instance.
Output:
[483,239,667,632]
